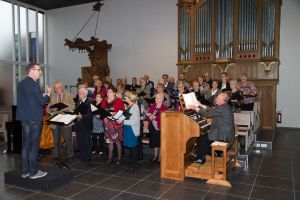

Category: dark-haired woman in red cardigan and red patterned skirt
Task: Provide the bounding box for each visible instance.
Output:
[101,86,125,165]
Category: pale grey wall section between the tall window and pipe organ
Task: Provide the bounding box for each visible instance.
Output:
[48,0,177,85]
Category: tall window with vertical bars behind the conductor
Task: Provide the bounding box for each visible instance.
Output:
[0,0,47,107]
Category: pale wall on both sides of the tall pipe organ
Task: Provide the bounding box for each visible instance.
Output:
[48,0,300,128]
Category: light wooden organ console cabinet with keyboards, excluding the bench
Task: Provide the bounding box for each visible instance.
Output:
[160,111,211,181]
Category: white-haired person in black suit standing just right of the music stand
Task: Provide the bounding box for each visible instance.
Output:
[75,87,93,163]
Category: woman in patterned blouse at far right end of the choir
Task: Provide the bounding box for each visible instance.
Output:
[237,74,257,111]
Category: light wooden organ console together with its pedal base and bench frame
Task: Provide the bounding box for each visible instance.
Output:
[161,110,236,185]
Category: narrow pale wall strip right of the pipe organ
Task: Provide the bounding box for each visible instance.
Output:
[277,0,300,128]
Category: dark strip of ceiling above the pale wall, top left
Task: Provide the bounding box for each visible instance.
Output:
[19,0,97,10]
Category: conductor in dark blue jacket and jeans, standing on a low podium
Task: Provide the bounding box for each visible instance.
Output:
[16,63,52,179]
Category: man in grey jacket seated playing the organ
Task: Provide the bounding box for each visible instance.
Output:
[188,92,234,164]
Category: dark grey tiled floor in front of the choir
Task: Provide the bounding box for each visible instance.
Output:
[0,129,300,200]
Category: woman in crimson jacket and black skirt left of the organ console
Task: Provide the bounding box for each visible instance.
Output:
[147,93,168,162]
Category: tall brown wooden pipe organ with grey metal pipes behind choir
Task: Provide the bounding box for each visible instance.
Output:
[177,0,281,130]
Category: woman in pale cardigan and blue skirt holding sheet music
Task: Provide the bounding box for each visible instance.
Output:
[119,91,140,170]
